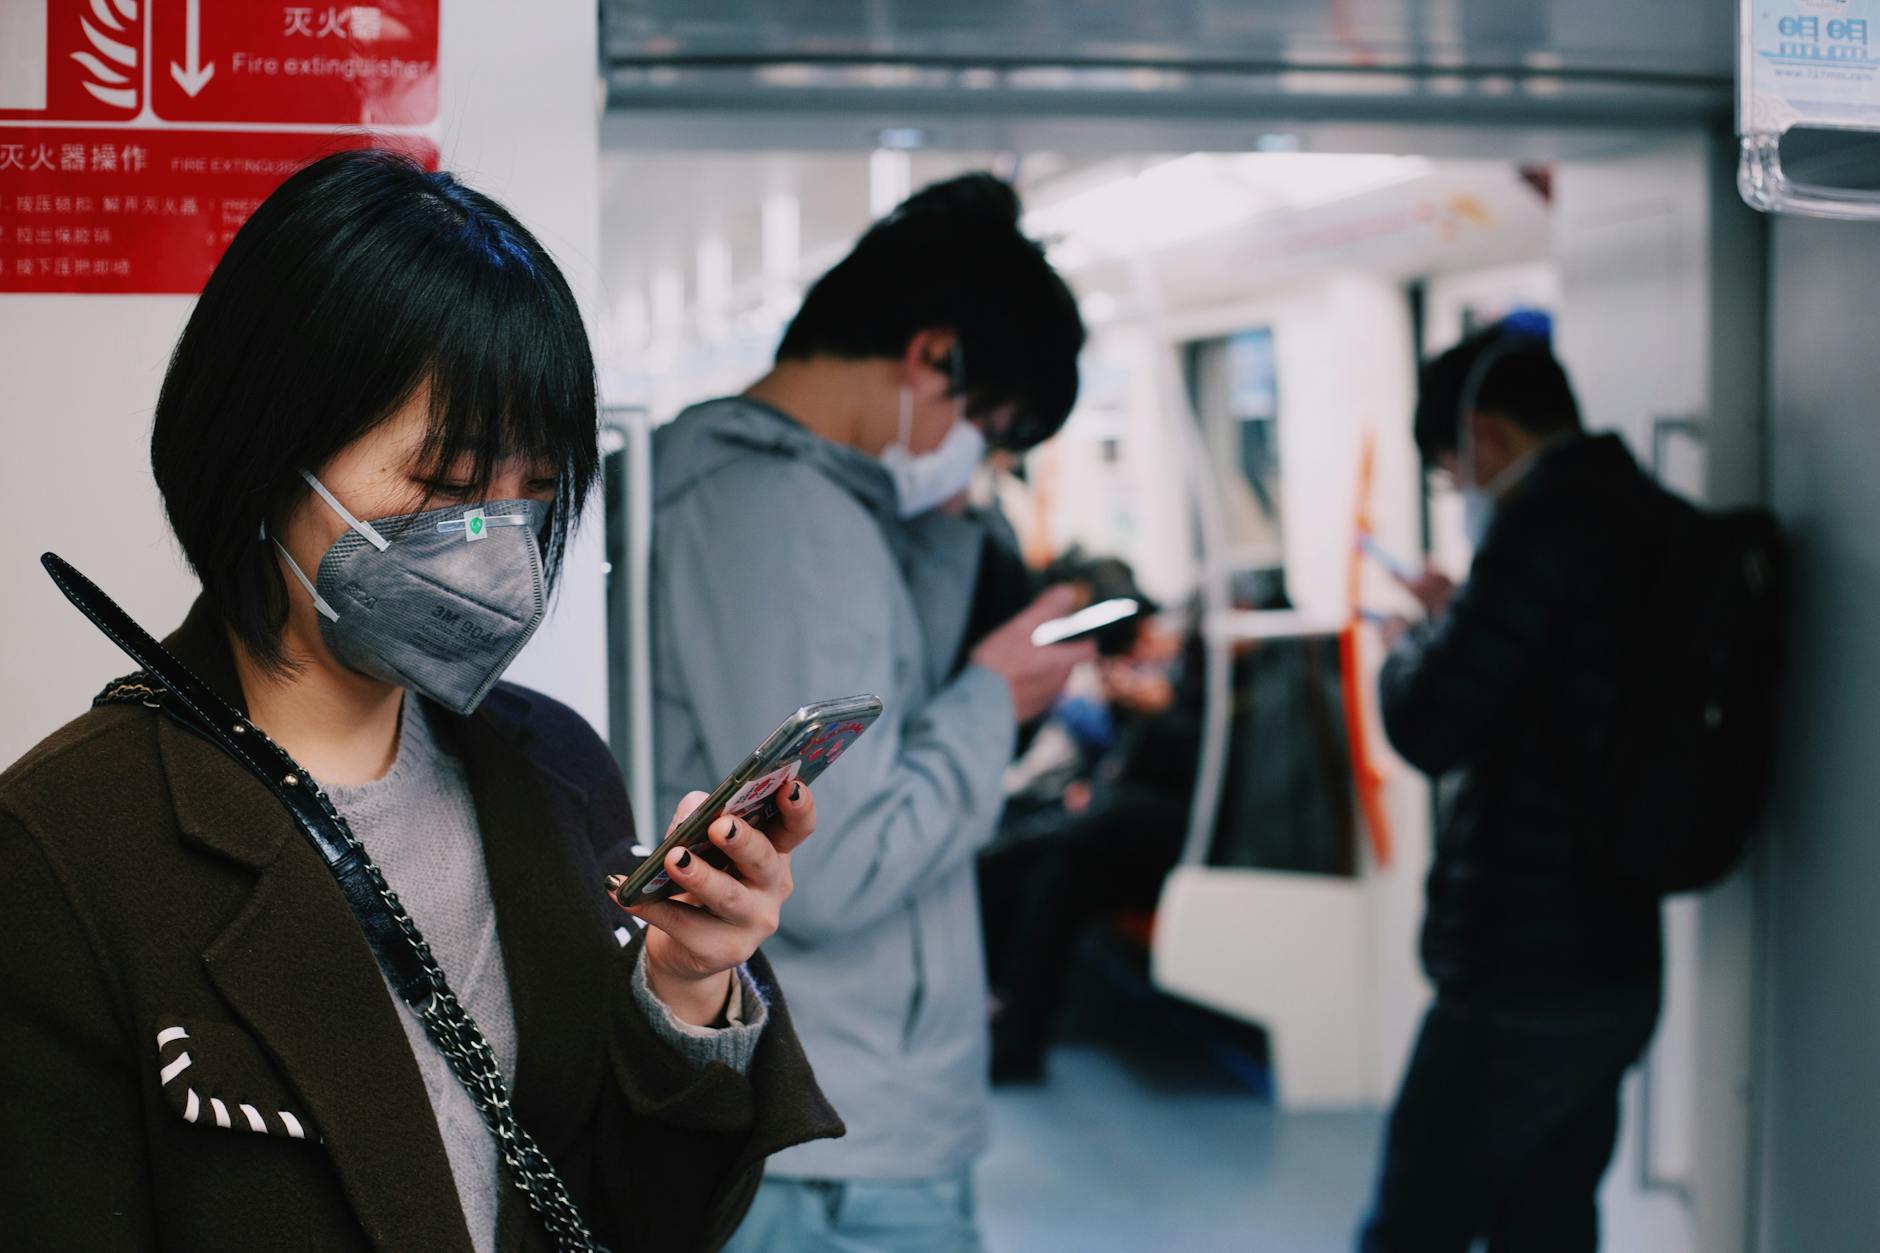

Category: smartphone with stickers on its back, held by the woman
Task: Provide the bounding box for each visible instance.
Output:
[615,696,882,901]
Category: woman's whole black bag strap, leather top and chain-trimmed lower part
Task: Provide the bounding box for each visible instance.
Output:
[39,553,605,1253]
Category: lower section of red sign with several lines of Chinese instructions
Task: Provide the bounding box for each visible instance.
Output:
[0,126,438,295]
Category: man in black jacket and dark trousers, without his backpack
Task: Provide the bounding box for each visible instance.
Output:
[1359,322,1662,1253]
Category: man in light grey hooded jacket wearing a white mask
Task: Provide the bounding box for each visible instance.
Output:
[652,175,1090,1253]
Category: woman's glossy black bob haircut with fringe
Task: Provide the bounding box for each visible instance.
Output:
[150,149,600,668]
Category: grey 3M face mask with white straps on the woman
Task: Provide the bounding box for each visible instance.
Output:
[263,470,549,713]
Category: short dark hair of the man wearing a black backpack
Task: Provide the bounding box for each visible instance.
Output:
[1416,318,1579,465]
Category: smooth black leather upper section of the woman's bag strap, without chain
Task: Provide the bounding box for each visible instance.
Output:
[39,553,432,1007]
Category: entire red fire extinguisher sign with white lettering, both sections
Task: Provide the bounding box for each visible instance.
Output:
[0,0,438,293]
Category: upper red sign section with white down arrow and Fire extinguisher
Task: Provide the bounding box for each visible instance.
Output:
[150,0,438,126]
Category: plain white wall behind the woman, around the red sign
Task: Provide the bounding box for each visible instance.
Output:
[0,0,607,764]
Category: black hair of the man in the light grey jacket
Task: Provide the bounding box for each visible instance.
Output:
[776,173,1083,452]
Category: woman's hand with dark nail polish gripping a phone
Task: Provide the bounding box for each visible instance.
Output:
[622,783,816,1027]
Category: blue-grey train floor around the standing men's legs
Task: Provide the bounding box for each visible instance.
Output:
[974,925,1696,1253]
